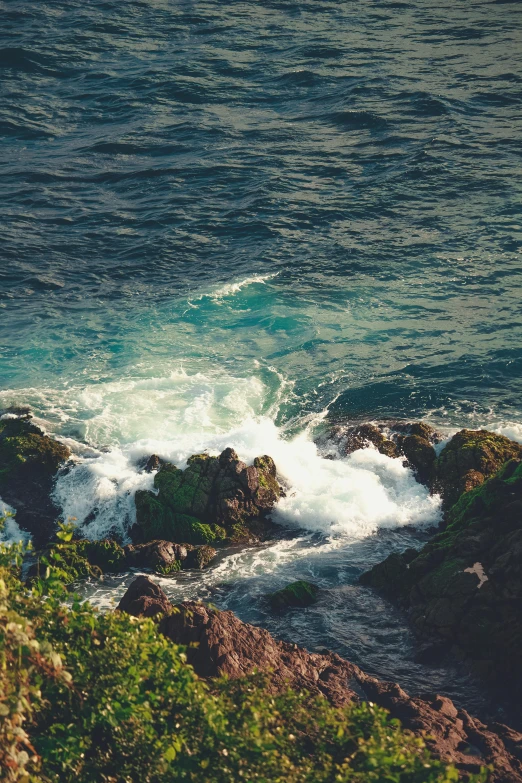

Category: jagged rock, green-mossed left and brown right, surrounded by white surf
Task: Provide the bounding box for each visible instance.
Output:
[131,448,281,544]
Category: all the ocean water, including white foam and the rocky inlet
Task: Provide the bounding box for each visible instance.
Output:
[0,0,522,712]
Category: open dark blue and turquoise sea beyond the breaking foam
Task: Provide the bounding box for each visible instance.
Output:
[0,0,522,422]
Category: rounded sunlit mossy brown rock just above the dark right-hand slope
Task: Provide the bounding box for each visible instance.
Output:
[433,430,522,508]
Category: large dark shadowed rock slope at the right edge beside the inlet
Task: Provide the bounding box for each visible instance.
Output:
[360,460,522,701]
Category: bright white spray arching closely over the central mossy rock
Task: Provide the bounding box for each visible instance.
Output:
[55,418,440,539]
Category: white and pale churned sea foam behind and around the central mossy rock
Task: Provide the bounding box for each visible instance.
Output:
[47,372,440,538]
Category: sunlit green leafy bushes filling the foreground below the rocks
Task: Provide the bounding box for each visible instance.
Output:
[0,516,485,783]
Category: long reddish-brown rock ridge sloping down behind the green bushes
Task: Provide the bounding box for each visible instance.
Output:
[119,577,522,783]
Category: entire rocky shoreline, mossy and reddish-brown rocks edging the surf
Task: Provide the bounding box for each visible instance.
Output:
[0,411,522,783]
